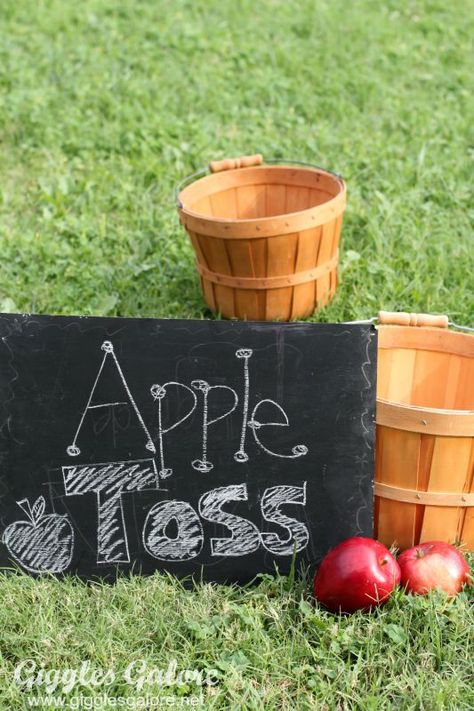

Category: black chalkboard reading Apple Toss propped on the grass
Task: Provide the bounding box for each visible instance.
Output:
[0,314,376,582]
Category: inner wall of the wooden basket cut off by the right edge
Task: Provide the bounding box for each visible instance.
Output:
[377,344,474,410]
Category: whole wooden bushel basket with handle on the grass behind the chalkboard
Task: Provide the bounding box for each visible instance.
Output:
[177,155,346,321]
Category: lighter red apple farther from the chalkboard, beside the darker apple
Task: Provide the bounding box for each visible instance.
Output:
[398,541,470,595]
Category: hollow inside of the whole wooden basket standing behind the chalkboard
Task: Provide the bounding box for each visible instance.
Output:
[180,166,343,220]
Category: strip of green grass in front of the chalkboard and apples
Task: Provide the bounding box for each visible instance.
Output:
[0,572,474,711]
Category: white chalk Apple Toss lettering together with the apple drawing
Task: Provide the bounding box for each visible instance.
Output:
[2,341,309,573]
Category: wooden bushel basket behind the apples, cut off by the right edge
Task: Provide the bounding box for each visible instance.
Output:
[375,312,474,550]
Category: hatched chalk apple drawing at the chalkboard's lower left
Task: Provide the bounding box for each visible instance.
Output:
[2,496,74,573]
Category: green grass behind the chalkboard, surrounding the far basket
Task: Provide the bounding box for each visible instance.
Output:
[0,0,474,323]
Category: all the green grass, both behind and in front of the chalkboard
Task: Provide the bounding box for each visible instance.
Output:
[0,0,474,711]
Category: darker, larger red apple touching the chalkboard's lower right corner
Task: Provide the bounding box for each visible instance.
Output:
[314,537,400,612]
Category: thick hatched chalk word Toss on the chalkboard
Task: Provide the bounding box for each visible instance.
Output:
[63,459,309,564]
